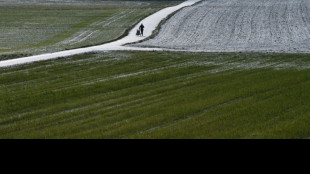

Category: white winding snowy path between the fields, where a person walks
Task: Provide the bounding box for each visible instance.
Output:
[0,0,201,67]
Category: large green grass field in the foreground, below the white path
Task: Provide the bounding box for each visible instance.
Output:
[0,52,310,139]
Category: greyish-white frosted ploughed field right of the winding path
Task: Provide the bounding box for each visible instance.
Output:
[135,0,310,53]
